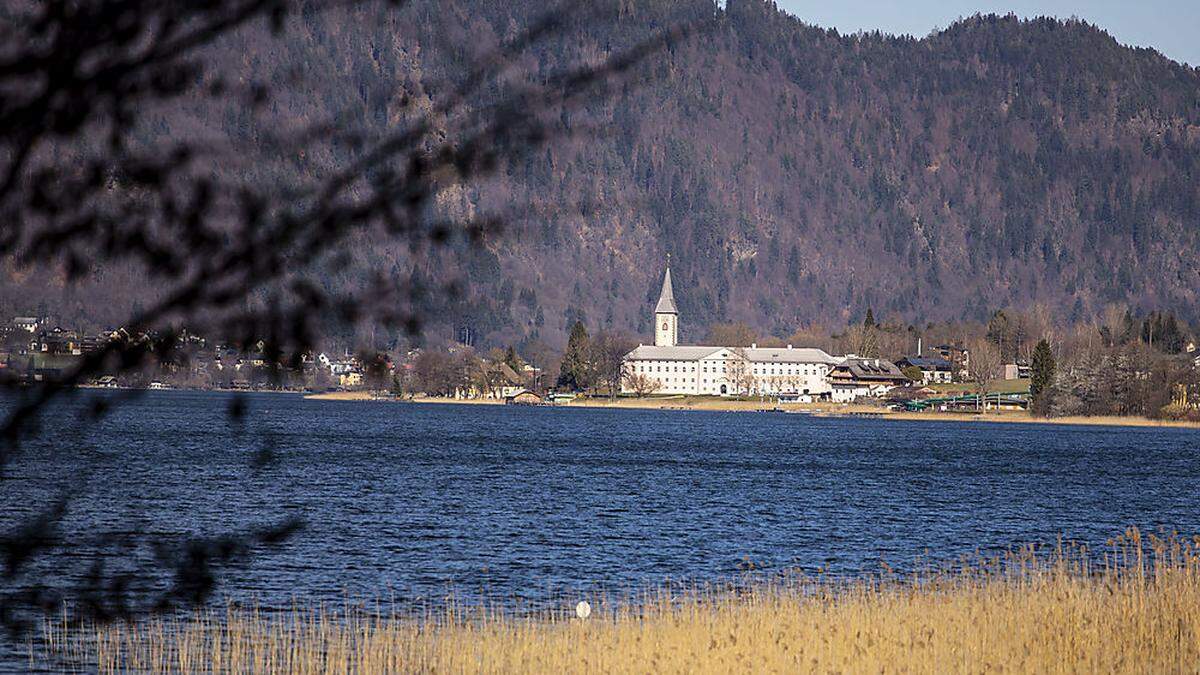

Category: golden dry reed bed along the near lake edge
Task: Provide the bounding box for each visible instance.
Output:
[32,530,1200,674]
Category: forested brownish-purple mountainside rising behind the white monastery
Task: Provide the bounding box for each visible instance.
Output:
[9,0,1200,344]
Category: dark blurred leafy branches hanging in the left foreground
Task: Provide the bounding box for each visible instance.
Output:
[0,0,688,629]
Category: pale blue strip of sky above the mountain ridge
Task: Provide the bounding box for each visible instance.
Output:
[776,0,1200,66]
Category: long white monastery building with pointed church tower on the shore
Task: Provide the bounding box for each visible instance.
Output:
[622,268,841,402]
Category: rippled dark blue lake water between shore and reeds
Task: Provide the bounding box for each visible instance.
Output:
[0,392,1200,619]
